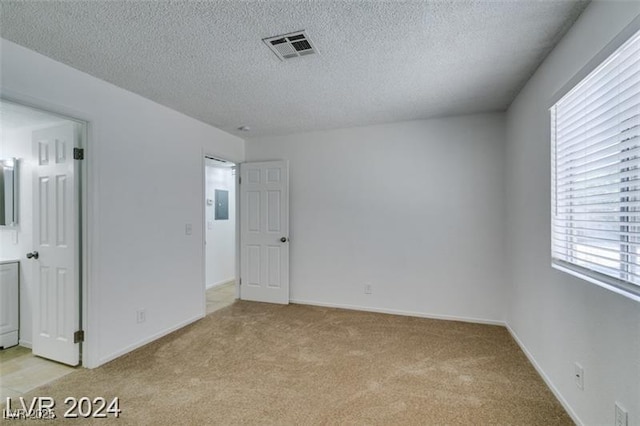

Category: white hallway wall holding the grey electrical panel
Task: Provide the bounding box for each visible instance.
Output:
[206,166,236,288]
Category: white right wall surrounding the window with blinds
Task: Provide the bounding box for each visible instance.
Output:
[506,1,640,426]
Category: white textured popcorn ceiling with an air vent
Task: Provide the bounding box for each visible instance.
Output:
[0,0,587,138]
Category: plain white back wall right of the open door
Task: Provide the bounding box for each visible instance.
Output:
[246,114,505,322]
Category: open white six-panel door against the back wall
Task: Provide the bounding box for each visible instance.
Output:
[240,161,289,304]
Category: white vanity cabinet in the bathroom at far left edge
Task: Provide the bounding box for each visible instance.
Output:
[0,261,20,348]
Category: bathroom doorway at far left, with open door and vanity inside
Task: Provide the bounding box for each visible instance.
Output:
[0,99,87,396]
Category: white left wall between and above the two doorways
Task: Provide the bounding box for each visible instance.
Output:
[0,40,244,367]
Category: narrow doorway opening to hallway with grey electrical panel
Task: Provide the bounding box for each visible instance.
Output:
[204,156,237,314]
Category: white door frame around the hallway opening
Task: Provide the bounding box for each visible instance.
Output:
[200,153,241,317]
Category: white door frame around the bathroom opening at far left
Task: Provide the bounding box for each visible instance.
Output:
[0,93,90,368]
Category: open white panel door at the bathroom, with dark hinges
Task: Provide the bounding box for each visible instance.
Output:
[29,123,80,365]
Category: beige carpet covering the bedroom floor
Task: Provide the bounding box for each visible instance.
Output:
[8,302,572,425]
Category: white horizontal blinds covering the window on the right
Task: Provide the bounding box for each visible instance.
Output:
[551,32,640,286]
